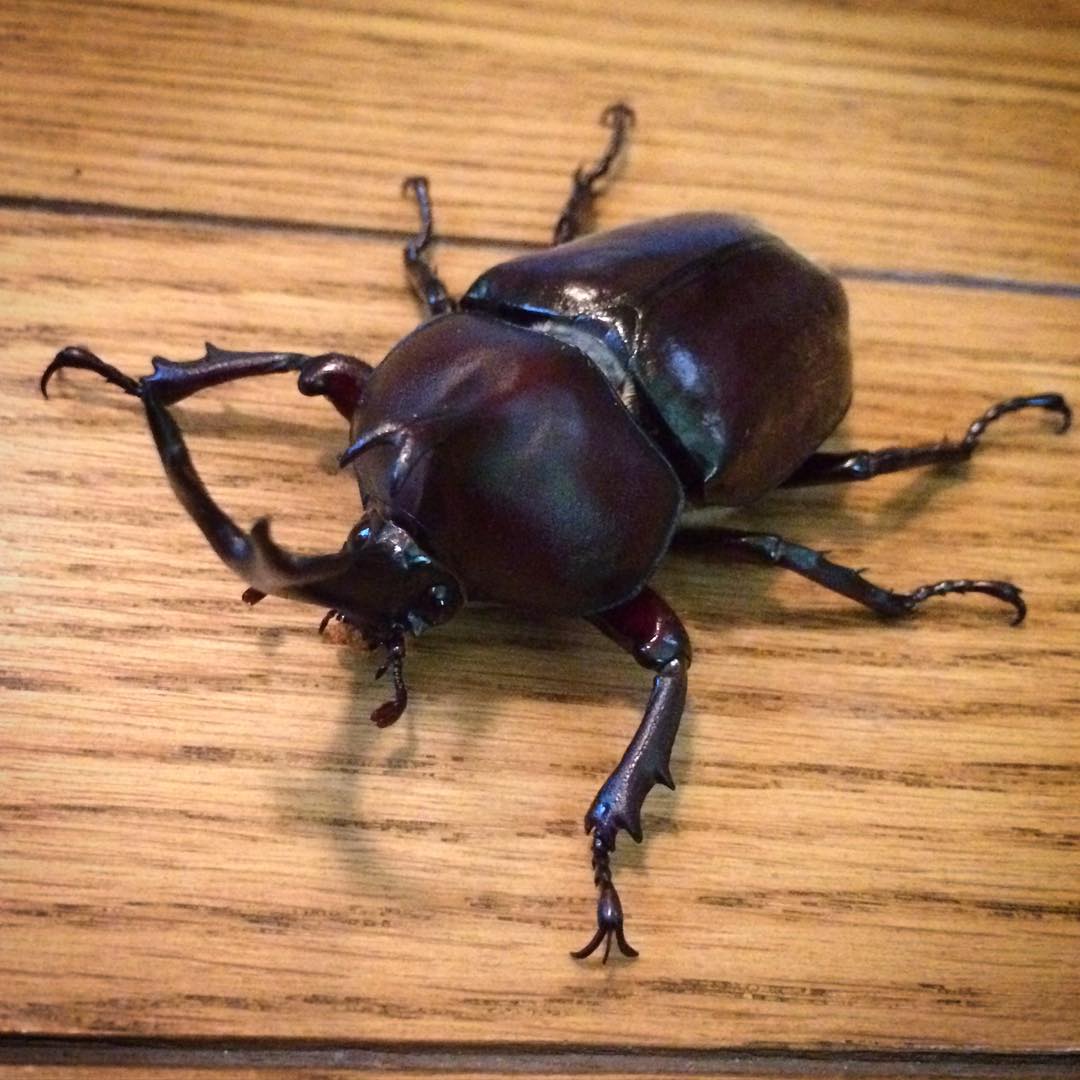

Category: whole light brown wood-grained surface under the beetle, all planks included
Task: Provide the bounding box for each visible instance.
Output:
[0,0,1080,1078]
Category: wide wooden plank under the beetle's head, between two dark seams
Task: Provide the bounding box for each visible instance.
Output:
[0,206,1080,1049]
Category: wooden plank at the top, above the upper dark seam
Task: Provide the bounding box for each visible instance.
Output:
[0,0,1080,284]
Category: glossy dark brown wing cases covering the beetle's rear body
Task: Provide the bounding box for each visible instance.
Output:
[464,214,851,505]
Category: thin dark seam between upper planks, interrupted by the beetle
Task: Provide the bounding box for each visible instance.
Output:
[0,194,1080,299]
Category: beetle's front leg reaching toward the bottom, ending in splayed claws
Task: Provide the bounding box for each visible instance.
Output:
[570,589,690,962]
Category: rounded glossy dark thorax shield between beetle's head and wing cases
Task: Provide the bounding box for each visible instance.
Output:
[353,314,683,615]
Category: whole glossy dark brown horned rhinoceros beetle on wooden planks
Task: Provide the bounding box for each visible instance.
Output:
[41,104,1071,962]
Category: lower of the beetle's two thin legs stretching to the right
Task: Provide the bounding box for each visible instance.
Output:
[710,529,1027,626]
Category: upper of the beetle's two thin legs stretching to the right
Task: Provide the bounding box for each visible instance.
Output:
[783,394,1072,487]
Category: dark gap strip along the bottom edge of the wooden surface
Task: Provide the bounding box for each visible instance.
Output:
[0,1034,1080,1080]
